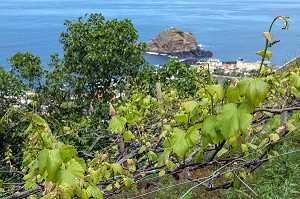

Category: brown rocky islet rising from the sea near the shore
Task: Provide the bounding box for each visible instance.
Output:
[147,28,213,58]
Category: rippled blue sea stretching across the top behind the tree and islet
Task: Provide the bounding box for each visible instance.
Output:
[0,0,300,69]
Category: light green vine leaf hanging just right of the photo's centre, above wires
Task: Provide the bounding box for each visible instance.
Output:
[170,128,189,158]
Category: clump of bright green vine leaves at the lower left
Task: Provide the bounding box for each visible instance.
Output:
[23,114,103,198]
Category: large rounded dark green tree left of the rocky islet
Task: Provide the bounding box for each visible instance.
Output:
[60,14,146,99]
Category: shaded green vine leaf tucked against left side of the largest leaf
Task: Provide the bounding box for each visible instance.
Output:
[201,115,224,144]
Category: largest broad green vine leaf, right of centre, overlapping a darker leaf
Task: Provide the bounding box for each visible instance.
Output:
[215,103,252,140]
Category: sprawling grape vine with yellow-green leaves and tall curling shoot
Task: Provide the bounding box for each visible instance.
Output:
[0,16,300,199]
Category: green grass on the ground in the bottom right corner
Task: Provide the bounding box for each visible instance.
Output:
[224,138,300,199]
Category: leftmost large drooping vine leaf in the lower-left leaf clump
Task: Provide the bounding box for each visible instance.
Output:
[38,149,63,181]
